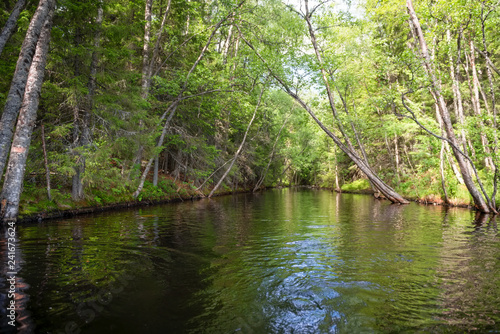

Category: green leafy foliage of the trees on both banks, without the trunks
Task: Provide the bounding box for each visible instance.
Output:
[6,0,500,219]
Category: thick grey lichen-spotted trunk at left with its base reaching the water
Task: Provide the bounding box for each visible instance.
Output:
[0,1,54,221]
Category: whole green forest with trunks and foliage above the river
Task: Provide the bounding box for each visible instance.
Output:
[0,0,500,221]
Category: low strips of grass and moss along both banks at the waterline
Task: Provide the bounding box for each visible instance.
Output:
[19,171,498,221]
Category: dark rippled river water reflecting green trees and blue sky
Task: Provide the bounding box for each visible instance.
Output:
[0,189,500,333]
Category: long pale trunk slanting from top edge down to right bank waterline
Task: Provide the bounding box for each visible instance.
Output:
[406,0,491,213]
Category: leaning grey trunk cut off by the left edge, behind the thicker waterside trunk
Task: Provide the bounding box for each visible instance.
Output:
[0,0,53,179]
